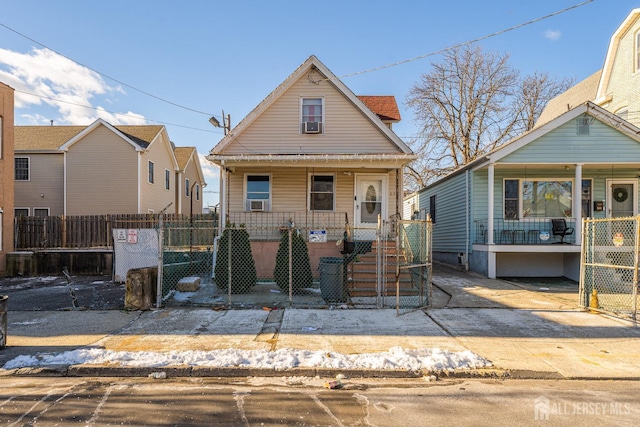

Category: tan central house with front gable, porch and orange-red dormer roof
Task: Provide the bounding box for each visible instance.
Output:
[208,56,415,276]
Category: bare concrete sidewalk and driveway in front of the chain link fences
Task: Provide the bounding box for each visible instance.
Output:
[0,266,640,379]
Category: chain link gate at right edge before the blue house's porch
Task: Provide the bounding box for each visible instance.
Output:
[580,216,640,320]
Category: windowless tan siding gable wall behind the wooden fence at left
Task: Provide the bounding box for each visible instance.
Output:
[67,126,139,215]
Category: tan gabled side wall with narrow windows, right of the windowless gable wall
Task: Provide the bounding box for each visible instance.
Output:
[140,134,176,213]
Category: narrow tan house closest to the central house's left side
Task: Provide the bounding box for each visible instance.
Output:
[172,147,206,215]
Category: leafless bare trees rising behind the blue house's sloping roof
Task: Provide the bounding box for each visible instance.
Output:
[406,45,570,189]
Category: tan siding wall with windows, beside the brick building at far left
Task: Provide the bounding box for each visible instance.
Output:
[15,153,64,216]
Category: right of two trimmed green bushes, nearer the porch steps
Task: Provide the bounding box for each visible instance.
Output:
[273,232,313,293]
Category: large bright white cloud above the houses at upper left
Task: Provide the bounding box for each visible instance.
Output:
[0,48,146,125]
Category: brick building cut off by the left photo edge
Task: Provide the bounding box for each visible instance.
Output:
[0,82,14,276]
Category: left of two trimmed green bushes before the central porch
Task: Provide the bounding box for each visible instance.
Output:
[215,226,258,294]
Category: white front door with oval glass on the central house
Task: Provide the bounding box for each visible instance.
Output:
[354,175,387,240]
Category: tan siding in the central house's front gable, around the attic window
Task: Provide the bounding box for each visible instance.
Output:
[224,73,398,155]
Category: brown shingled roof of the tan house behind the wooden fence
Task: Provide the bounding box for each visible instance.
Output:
[14,119,164,151]
